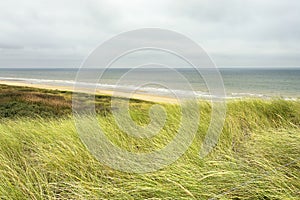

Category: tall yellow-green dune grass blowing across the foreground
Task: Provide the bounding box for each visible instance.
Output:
[0,86,300,199]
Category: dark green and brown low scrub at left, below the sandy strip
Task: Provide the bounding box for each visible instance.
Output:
[0,84,151,119]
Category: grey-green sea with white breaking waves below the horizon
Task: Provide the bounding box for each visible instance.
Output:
[0,68,300,99]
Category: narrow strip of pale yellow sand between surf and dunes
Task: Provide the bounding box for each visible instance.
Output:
[0,81,178,104]
